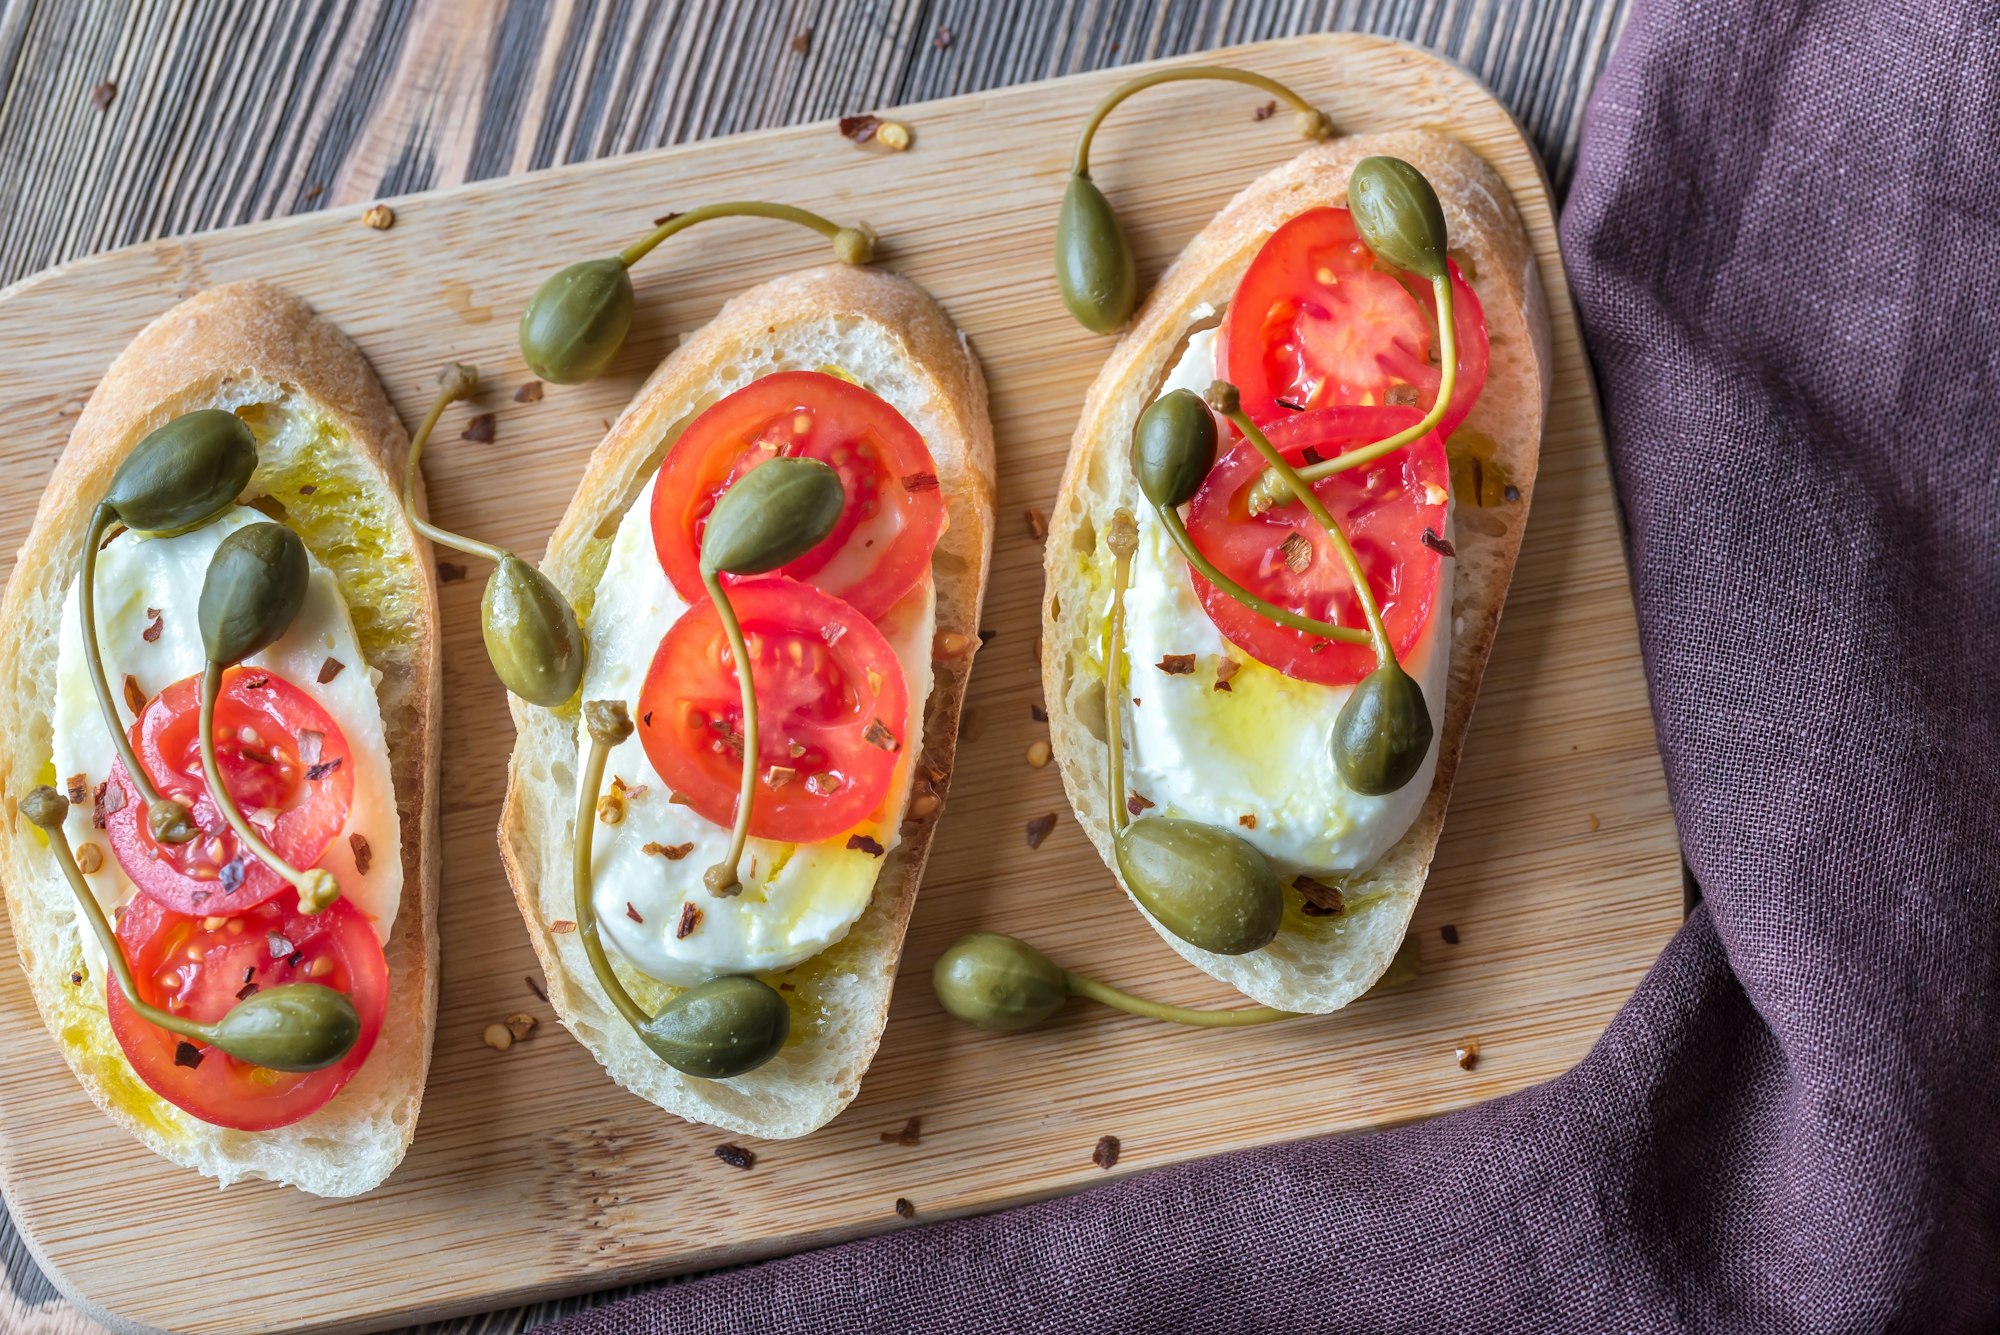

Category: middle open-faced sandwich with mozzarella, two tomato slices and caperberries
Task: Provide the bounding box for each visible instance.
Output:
[500,259,994,1137]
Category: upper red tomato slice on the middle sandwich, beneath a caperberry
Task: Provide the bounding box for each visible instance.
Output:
[652,372,944,620]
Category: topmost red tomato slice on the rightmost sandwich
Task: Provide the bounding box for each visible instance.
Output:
[1220,208,1488,435]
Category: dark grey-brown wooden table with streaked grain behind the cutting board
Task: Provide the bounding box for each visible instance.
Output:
[0,0,1628,1335]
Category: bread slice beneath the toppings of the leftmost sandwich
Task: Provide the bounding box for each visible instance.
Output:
[0,282,438,1195]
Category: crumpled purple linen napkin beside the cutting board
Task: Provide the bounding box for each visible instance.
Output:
[554,0,2000,1335]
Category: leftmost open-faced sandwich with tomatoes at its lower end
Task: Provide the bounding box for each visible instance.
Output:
[0,284,438,1195]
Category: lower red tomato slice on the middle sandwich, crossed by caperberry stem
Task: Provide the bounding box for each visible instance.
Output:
[638,576,910,843]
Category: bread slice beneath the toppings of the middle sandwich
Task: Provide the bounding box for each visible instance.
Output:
[500,266,994,1139]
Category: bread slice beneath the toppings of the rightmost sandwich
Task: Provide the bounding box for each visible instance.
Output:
[1042,132,1548,1011]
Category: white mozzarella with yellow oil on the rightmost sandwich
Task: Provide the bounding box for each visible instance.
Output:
[1104,330,1452,873]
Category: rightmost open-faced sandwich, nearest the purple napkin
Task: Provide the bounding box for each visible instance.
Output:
[1042,118,1548,1011]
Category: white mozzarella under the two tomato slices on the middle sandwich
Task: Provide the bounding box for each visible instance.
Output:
[578,478,936,985]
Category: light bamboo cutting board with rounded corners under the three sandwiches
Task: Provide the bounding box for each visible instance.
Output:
[0,36,1680,1331]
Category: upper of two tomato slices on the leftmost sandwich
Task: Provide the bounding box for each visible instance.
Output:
[102,668,354,915]
